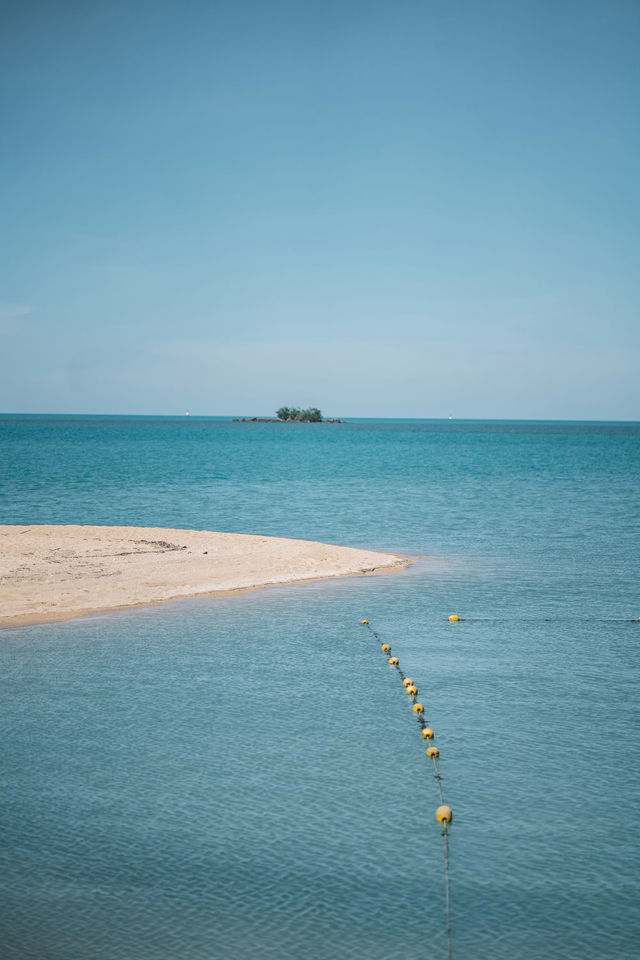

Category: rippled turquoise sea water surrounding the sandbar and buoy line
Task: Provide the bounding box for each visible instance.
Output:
[0,416,640,960]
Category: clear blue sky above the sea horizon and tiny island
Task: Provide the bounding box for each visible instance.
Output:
[0,0,640,419]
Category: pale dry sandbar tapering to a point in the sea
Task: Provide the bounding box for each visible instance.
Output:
[0,525,408,627]
